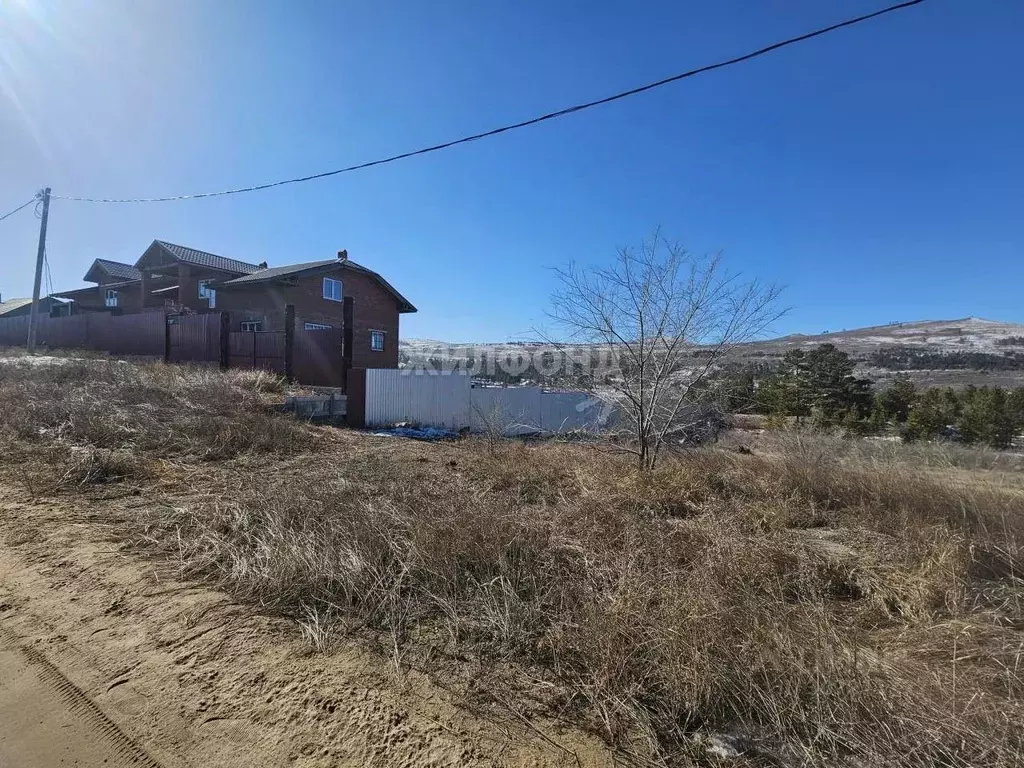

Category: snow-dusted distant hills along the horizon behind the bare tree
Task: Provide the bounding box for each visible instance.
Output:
[400,317,1024,387]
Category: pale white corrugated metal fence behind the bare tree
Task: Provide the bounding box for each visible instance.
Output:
[365,369,608,435]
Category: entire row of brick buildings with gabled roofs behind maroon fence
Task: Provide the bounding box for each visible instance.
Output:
[54,240,416,368]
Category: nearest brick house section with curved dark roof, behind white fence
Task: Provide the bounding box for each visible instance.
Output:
[212,251,416,368]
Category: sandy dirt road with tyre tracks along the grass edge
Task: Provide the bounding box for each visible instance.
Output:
[0,476,613,768]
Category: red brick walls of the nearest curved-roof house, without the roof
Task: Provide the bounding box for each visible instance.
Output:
[217,267,398,368]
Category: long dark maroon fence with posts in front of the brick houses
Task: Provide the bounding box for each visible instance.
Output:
[0,307,349,387]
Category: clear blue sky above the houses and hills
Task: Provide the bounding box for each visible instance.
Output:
[0,0,1024,341]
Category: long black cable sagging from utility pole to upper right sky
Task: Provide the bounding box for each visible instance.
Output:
[52,0,925,203]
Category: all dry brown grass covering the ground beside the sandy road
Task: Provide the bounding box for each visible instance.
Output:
[0,358,1024,767]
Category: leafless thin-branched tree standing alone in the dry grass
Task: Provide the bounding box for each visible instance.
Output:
[548,231,784,469]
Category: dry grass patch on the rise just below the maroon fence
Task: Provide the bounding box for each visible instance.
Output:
[0,358,315,460]
